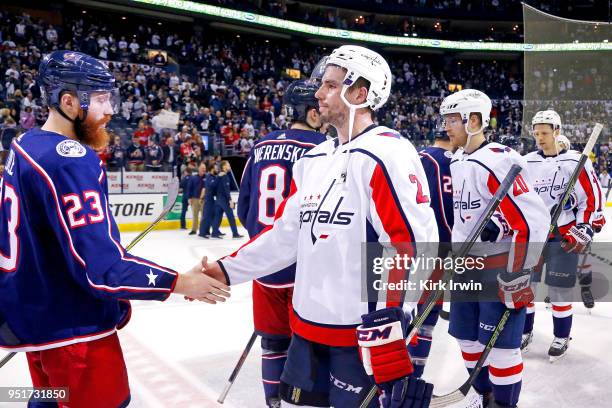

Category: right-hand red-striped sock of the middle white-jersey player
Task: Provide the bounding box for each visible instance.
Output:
[489,347,523,407]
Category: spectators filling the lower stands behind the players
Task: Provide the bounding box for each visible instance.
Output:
[0,6,612,180]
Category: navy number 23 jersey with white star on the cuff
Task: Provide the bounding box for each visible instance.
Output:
[0,129,178,351]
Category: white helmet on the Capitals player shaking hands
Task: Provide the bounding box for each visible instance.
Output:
[326,45,391,110]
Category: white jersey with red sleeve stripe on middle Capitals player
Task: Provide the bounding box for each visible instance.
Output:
[451,142,550,272]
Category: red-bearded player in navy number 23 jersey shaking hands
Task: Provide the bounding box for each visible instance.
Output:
[0,51,228,408]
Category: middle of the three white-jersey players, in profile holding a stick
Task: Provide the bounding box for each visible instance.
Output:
[440,89,550,407]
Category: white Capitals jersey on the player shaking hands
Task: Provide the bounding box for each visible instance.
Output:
[220,125,438,346]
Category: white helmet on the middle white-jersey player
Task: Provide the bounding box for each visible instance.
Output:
[440,89,492,135]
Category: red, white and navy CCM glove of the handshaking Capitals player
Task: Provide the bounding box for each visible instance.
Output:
[357,307,414,392]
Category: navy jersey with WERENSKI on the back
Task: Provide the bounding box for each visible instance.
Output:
[238,129,326,287]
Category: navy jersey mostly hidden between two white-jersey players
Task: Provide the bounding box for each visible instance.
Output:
[419,146,453,242]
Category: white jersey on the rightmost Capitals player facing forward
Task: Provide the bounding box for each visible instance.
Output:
[525,150,602,233]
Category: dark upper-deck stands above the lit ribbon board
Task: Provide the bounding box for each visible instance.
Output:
[199,0,595,42]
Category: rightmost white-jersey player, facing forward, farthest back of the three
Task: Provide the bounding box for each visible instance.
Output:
[521,110,605,361]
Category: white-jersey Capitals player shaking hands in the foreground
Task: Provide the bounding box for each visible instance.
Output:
[206,45,438,407]
